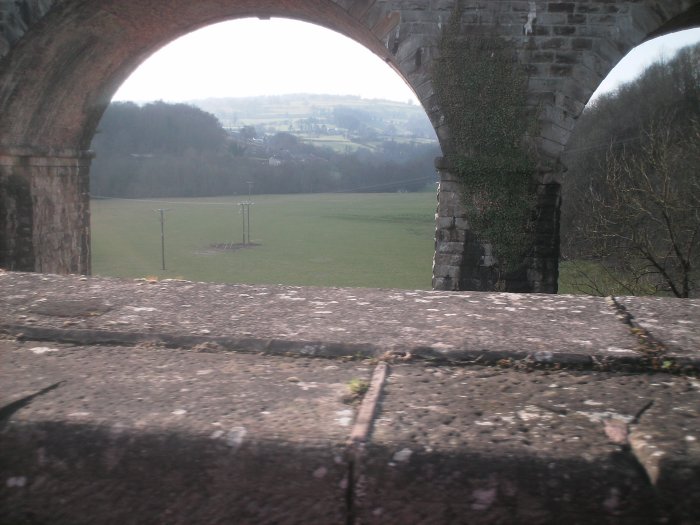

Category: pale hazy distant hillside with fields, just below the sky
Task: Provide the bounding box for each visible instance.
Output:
[190,94,437,150]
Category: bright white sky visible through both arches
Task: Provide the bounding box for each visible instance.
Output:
[114,19,700,102]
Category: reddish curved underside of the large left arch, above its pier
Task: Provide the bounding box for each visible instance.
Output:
[0,0,432,150]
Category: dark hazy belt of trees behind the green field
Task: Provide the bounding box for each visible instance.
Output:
[90,102,439,198]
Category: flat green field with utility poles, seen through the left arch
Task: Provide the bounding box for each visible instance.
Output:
[91,192,436,289]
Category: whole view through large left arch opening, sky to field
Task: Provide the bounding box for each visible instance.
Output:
[91,19,440,289]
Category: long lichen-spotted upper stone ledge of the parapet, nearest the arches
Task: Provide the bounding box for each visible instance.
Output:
[0,272,697,366]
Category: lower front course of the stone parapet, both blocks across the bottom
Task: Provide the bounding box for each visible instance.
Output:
[0,340,700,525]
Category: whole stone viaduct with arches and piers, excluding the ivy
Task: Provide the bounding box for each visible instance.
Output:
[0,0,700,293]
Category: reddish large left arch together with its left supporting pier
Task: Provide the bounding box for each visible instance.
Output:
[0,0,434,273]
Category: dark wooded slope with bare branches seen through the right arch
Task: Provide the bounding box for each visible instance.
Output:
[562,45,700,297]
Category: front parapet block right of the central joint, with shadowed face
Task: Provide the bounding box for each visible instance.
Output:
[356,364,700,524]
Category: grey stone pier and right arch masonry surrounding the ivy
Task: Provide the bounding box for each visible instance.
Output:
[433,0,700,293]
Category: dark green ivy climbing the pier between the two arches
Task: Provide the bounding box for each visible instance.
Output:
[433,8,535,274]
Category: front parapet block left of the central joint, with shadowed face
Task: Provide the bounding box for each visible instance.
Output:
[0,340,370,525]
